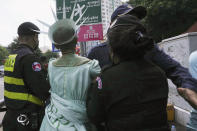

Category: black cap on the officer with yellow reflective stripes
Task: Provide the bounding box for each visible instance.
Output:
[17,22,40,35]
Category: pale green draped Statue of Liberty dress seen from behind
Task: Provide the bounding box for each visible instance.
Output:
[40,54,100,131]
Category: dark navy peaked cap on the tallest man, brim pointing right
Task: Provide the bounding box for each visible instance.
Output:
[111,4,147,22]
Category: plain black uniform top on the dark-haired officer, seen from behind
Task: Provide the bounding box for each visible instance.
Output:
[87,60,169,131]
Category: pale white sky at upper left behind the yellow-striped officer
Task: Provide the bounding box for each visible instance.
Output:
[0,0,128,48]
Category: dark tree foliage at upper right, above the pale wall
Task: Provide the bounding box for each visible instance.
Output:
[129,0,197,41]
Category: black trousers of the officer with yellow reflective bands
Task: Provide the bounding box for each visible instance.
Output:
[2,110,39,131]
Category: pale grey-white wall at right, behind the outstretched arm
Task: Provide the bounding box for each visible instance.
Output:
[159,32,197,125]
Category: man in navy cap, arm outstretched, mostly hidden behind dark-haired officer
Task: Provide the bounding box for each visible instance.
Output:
[88,4,197,108]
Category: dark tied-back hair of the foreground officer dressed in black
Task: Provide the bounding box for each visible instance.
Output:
[108,25,154,60]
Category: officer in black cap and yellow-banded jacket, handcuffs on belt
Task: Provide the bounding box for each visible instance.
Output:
[3,22,50,131]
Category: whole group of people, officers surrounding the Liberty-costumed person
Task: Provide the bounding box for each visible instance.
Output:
[3,4,197,131]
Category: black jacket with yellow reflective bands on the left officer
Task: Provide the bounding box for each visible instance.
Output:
[4,45,50,112]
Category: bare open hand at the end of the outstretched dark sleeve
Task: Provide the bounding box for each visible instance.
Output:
[177,88,197,110]
